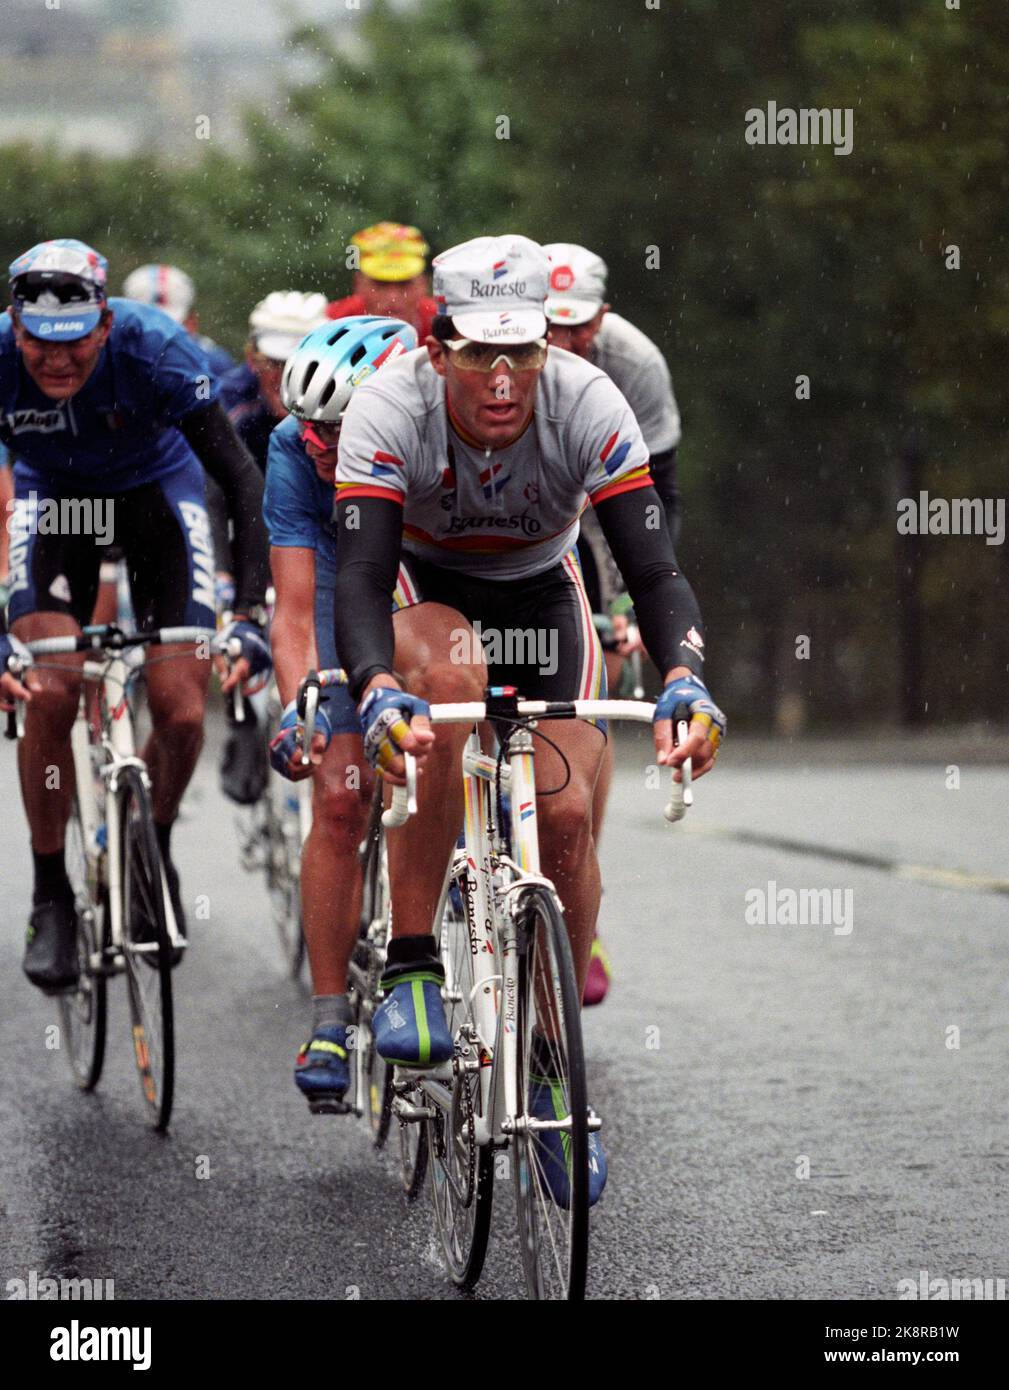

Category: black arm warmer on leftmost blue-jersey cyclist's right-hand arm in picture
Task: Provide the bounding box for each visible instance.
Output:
[179,400,270,613]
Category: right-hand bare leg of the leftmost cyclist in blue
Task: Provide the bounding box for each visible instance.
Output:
[143,646,210,826]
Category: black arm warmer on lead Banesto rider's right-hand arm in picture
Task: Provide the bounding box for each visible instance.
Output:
[596,488,705,677]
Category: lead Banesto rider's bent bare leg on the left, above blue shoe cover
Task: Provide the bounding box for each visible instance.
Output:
[388,603,486,937]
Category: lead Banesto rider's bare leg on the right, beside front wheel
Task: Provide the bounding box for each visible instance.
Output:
[534,720,605,990]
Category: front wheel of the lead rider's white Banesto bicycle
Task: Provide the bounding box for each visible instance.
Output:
[514,888,589,1300]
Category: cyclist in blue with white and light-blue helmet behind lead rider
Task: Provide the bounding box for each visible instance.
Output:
[263,317,417,1108]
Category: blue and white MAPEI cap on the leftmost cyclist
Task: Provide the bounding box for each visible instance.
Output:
[8,236,108,342]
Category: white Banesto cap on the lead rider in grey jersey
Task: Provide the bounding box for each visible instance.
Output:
[431,236,550,343]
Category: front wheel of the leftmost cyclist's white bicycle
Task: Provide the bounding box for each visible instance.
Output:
[118,767,175,1131]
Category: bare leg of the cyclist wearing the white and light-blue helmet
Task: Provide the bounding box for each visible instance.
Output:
[302,734,372,995]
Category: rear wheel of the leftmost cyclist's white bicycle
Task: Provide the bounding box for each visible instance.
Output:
[60,795,107,1091]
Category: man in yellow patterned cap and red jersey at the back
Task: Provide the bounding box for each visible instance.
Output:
[327,222,438,343]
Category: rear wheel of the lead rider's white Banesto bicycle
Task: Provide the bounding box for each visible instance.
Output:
[427,873,493,1289]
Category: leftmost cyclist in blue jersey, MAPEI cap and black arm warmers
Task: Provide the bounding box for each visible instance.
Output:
[0,239,270,990]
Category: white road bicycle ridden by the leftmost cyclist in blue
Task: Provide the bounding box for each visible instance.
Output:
[7,623,214,1131]
